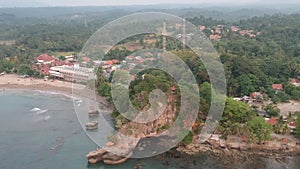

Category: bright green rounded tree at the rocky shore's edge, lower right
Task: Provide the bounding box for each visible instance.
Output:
[247,117,272,144]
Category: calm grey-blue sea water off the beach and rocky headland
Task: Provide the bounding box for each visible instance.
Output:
[0,91,300,169]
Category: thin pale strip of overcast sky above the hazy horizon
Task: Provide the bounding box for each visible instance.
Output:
[0,0,300,7]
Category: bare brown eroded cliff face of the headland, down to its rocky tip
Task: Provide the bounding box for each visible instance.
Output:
[86,94,177,165]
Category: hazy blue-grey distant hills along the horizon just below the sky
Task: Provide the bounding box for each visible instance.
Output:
[0,3,300,21]
